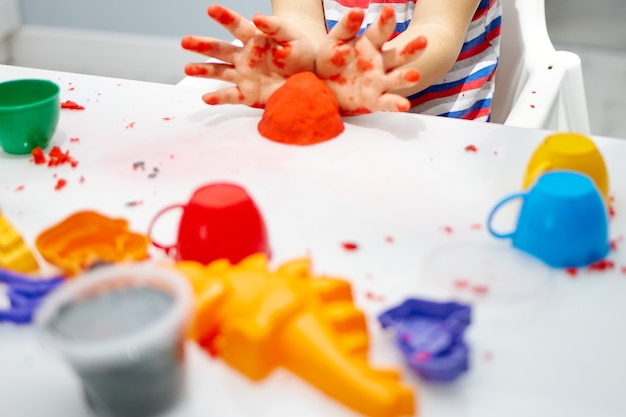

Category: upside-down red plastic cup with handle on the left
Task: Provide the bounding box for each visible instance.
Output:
[148,183,270,265]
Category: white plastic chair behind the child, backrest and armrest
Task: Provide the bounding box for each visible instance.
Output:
[492,0,590,134]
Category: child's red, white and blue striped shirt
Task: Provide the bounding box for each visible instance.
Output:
[323,0,502,121]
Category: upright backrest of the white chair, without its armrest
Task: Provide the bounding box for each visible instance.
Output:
[491,0,555,123]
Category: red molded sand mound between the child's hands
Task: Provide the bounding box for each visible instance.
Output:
[259,72,344,145]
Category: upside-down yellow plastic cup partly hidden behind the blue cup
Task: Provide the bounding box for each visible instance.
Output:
[522,132,610,206]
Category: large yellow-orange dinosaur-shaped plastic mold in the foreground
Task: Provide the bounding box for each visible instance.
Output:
[176,254,415,417]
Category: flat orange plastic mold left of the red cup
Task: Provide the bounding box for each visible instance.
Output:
[35,211,150,276]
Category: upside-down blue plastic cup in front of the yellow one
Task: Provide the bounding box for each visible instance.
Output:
[487,171,610,268]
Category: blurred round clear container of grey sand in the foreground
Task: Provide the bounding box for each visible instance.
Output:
[36,263,193,417]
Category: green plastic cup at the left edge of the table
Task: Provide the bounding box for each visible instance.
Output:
[0,79,61,154]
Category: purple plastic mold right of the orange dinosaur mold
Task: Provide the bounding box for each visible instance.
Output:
[378,299,471,382]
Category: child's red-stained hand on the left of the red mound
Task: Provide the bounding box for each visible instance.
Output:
[181,5,315,107]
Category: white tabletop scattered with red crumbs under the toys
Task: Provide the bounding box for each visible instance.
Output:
[0,66,626,417]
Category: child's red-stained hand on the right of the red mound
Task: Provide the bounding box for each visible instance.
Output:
[317,6,426,116]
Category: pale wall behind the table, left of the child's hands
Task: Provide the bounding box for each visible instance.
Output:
[7,0,271,84]
